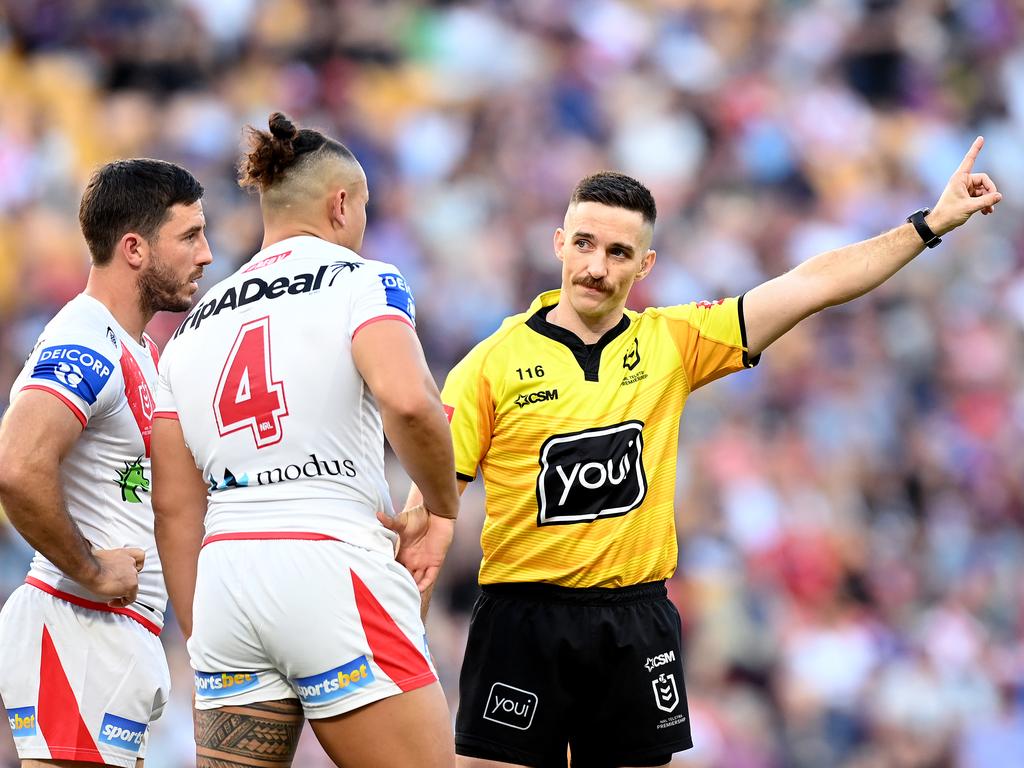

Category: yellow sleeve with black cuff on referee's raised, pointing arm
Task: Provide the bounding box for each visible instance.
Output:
[655,296,760,391]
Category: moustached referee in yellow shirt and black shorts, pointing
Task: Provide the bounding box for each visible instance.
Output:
[384,137,1001,768]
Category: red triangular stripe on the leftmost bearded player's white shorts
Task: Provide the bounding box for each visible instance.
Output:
[37,627,106,763]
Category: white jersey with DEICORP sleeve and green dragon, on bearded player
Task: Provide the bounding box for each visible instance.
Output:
[11,294,167,633]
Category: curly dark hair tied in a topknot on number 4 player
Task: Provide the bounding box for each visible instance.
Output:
[239,112,358,193]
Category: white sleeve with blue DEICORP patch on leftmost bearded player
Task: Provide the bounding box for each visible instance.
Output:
[11,329,120,429]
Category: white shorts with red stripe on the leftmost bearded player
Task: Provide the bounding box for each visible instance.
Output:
[0,585,171,768]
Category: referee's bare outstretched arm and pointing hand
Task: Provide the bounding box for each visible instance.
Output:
[743,136,1002,356]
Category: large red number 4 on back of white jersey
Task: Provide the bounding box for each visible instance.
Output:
[213,317,288,449]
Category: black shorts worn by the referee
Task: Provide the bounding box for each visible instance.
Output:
[456,582,693,768]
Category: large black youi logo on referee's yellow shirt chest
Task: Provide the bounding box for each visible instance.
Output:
[537,421,647,525]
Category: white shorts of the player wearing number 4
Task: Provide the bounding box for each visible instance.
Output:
[188,539,437,719]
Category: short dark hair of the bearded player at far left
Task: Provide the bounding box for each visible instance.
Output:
[78,158,203,266]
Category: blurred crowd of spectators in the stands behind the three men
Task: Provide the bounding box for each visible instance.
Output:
[0,0,1024,768]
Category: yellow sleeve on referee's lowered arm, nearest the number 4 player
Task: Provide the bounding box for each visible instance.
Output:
[441,345,495,482]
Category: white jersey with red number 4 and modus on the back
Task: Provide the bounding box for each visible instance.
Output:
[156,236,415,553]
